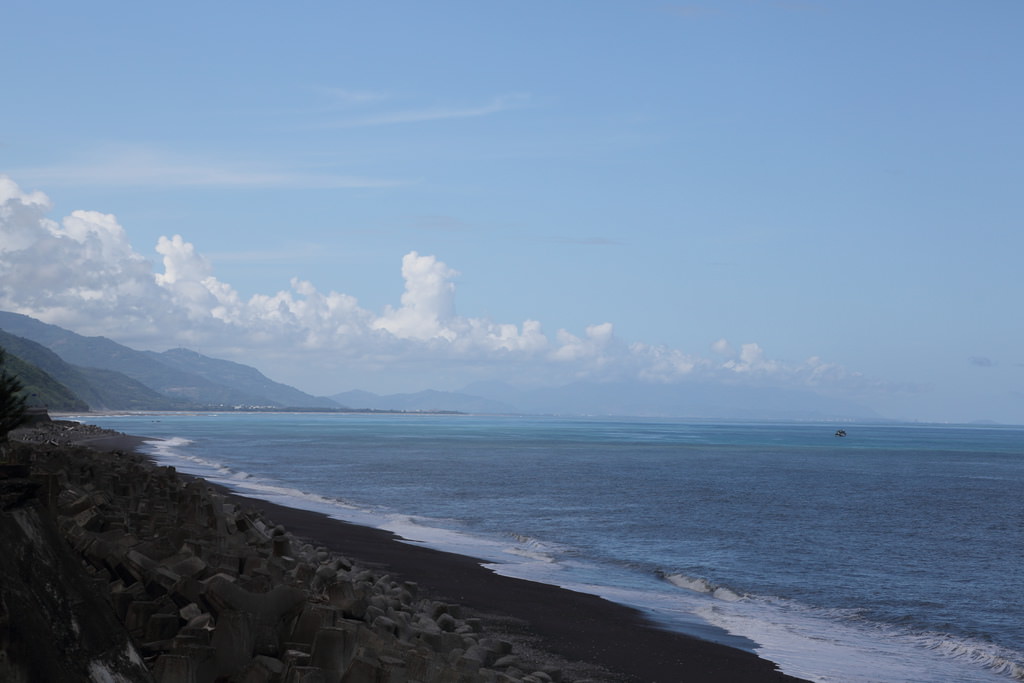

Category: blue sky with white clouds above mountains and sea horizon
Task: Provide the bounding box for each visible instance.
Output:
[0,0,1024,424]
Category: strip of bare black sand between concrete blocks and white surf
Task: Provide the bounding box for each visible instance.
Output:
[77,434,803,683]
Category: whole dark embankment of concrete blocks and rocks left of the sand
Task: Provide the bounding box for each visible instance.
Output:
[0,422,561,683]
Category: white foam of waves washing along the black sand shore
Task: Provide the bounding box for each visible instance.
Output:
[132,438,1024,683]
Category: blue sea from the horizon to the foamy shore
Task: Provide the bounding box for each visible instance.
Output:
[81,413,1024,683]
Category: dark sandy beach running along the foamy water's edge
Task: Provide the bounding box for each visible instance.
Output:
[8,423,798,683]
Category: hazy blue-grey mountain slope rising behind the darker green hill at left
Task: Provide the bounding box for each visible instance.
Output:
[0,311,335,410]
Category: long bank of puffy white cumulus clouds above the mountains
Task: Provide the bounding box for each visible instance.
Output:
[0,175,856,393]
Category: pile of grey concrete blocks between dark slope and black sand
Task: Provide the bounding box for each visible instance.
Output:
[0,428,540,683]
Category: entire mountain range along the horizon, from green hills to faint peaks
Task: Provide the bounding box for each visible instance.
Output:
[0,311,879,420]
